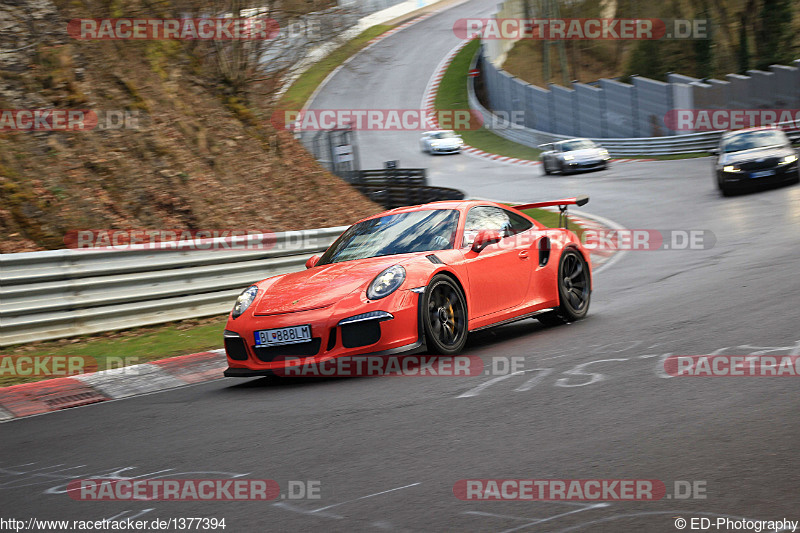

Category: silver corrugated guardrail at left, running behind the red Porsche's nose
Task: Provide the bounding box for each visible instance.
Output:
[0,226,346,346]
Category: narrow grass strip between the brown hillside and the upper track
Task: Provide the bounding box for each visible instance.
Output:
[278,24,394,110]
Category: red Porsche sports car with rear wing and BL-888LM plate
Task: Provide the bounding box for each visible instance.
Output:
[224,196,592,377]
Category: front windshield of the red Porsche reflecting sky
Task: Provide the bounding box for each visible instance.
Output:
[317,209,458,265]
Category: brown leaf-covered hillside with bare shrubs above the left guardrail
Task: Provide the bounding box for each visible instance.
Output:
[0,0,380,253]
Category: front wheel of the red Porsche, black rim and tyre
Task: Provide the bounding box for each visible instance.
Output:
[422,274,468,355]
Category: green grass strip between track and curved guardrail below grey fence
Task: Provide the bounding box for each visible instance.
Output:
[444,39,710,161]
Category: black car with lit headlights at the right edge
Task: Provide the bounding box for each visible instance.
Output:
[715,127,800,196]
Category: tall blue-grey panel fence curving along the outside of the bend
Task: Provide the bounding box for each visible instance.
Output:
[474,0,800,148]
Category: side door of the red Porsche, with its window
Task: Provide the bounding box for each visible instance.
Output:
[462,206,537,318]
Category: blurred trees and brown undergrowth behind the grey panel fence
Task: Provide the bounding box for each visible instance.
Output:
[503,0,800,87]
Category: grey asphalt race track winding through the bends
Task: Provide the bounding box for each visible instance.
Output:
[0,1,800,531]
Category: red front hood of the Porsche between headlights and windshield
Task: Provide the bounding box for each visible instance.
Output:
[254,256,409,316]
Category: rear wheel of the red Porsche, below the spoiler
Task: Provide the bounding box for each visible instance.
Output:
[536,249,592,326]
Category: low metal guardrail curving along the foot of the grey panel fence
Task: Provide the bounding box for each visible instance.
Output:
[467,49,800,156]
